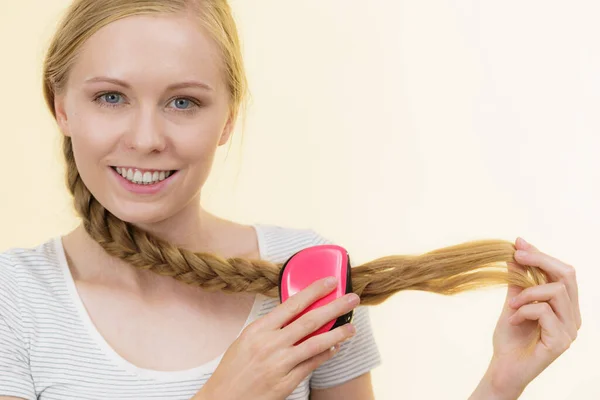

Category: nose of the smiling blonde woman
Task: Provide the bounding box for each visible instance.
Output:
[125,107,167,153]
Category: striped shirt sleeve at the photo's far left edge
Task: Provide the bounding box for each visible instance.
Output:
[0,254,36,400]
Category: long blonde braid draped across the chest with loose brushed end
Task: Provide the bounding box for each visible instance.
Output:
[63,137,545,305]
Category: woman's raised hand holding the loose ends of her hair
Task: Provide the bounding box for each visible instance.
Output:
[471,238,581,400]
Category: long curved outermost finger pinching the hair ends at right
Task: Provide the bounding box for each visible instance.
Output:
[514,250,581,329]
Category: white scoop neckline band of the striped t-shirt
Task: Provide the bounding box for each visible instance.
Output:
[53,224,266,381]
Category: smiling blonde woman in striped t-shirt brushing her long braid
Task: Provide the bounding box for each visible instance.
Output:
[0,0,581,400]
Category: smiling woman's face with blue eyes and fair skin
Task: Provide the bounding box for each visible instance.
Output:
[55,16,232,223]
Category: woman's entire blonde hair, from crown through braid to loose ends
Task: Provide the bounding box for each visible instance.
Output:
[44,0,547,312]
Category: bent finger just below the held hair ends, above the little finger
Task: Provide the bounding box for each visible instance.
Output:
[510,282,577,340]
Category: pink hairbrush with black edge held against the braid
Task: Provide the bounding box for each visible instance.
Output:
[279,244,354,345]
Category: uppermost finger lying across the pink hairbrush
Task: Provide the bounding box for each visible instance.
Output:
[255,278,336,330]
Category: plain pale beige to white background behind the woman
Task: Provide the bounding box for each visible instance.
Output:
[0,0,600,400]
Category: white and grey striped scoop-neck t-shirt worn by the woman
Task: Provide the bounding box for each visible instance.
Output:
[0,224,381,400]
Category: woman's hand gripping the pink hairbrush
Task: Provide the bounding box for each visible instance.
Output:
[194,279,360,400]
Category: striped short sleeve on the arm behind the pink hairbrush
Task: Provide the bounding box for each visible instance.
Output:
[310,230,382,389]
